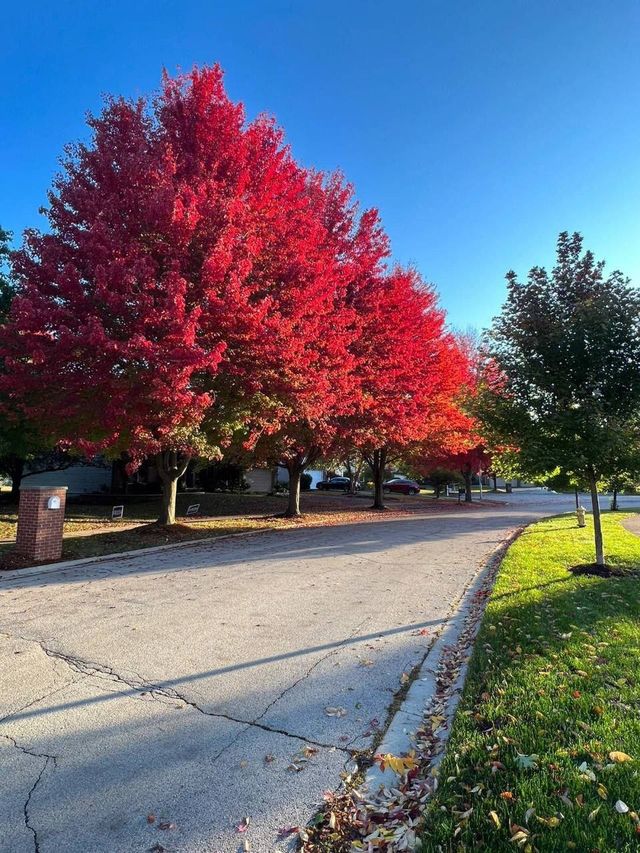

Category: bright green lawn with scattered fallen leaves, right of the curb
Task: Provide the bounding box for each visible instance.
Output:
[422,513,640,853]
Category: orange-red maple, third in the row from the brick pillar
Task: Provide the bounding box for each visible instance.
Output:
[345,267,469,509]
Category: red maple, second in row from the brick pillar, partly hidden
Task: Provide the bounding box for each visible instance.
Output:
[236,174,388,516]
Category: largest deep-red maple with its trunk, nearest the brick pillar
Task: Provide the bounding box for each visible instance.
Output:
[3,67,348,523]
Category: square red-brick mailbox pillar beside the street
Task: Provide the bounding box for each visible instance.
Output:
[16,486,67,563]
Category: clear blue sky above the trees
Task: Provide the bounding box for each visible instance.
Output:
[0,0,640,328]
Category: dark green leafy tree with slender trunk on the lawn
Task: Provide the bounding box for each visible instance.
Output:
[482,232,640,564]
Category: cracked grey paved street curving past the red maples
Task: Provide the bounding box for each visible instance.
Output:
[0,493,600,853]
